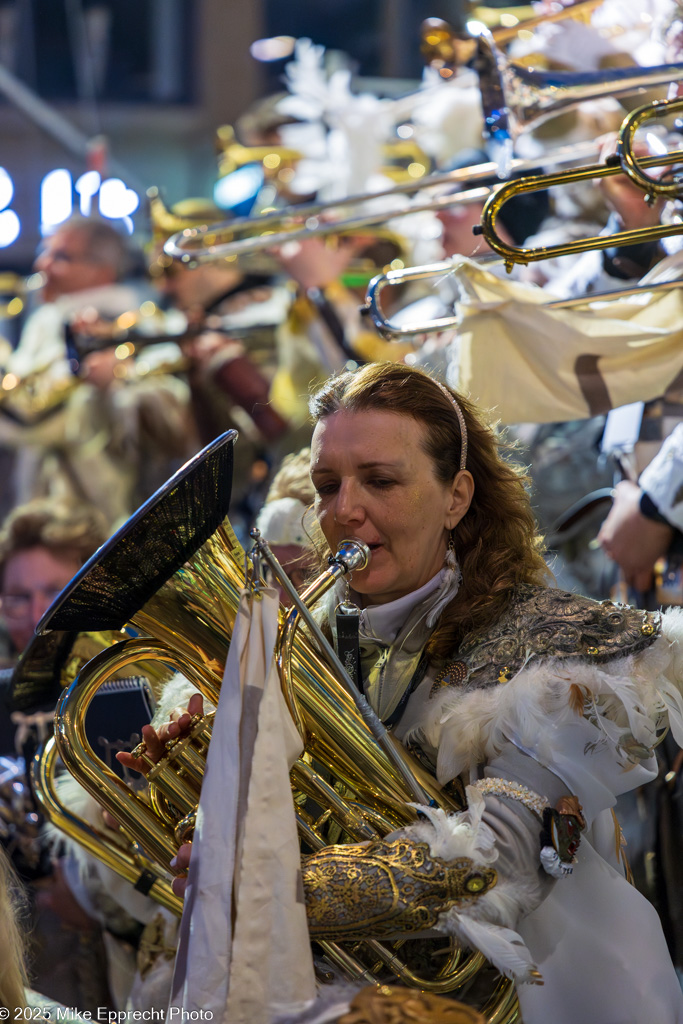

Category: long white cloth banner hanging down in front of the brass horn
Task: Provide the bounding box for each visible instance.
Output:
[171,589,315,1024]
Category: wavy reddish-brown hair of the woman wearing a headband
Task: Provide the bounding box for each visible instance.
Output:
[310,362,551,659]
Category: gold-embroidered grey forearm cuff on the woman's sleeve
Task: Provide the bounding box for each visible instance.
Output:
[302,839,497,939]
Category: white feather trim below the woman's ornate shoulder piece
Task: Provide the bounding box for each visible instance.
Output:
[403,622,683,784]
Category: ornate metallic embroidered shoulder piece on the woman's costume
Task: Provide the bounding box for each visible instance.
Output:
[432,584,660,693]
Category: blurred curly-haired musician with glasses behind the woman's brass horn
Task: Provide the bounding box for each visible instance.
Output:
[0,499,116,1010]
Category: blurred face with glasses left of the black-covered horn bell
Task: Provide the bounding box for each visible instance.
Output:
[0,546,83,653]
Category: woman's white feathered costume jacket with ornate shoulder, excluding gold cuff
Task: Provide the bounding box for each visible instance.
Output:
[304,573,683,1024]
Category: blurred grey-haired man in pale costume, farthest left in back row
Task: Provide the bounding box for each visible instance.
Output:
[0,217,188,526]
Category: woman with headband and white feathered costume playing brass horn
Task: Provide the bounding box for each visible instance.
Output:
[122,364,683,1024]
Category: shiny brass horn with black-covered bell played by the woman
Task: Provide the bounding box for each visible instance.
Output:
[39,431,518,1024]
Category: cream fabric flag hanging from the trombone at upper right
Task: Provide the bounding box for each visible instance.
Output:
[449,259,683,423]
